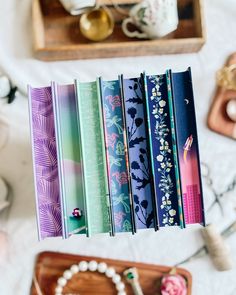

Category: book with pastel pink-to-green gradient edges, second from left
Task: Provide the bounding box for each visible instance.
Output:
[52,82,86,238]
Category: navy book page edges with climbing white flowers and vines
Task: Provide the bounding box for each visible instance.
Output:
[144,75,180,227]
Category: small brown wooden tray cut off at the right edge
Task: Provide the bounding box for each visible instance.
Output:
[208,52,236,139]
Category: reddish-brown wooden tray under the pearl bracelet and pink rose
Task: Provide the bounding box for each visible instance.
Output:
[30,252,192,295]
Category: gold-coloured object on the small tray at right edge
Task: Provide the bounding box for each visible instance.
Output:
[216,64,236,90]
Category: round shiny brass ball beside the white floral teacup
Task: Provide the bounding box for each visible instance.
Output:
[80,8,114,41]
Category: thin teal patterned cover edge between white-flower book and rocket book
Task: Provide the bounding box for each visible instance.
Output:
[166,71,185,228]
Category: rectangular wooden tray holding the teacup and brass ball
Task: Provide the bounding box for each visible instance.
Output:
[32,0,205,61]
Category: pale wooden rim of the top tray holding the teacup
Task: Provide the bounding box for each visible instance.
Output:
[32,0,206,61]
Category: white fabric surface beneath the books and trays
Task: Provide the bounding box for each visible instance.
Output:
[0,0,236,295]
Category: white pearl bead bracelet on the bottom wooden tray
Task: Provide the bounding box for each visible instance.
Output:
[55,260,126,295]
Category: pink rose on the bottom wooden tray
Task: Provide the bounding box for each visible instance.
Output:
[161,275,187,295]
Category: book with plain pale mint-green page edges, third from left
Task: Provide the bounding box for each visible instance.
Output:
[75,80,112,236]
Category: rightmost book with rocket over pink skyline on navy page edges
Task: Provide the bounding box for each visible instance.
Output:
[170,69,205,225]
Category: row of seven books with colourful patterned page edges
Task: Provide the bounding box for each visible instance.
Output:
[28,68,205,239]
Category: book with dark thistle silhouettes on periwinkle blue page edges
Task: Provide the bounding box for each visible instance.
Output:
[123,78,154,228]
